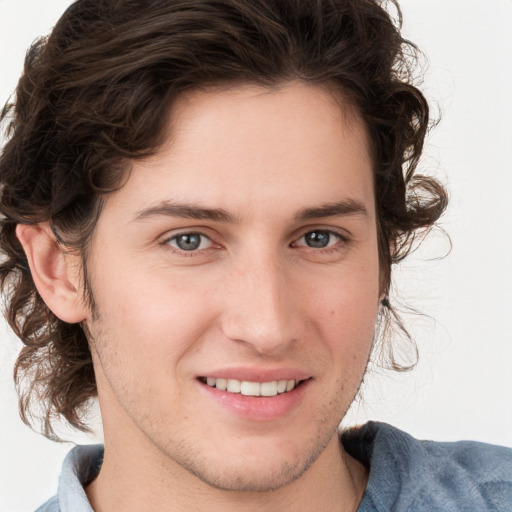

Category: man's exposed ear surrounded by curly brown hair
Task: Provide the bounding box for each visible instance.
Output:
[16,223,88,323]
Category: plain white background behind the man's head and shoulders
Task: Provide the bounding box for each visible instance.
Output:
[0,0,512,512]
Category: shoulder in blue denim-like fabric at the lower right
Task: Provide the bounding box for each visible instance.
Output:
[342,422,512,512]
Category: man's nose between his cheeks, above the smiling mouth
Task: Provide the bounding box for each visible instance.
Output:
[222,254,304,355]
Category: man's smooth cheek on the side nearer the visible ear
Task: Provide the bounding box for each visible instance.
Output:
[94,272,220,371]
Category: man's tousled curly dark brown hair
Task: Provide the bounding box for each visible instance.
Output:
[0,0,447,437]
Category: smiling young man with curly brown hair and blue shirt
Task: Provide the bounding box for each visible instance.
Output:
[0,0,511,511]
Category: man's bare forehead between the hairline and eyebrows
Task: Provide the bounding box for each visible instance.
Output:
[105,83,373,220]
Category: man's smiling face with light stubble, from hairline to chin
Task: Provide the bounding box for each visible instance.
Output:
[83,84,379,490]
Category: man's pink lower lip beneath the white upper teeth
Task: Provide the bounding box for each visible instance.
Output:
[198,380,311,421]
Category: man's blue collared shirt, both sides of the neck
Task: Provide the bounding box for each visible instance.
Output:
[36,422,512,512]
